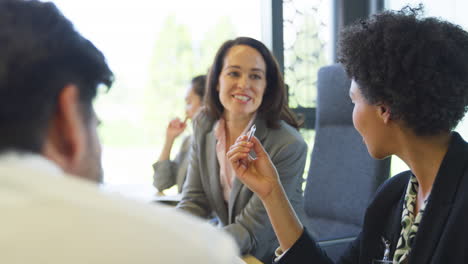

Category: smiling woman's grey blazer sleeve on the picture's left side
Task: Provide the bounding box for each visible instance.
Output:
[176,132,211,218]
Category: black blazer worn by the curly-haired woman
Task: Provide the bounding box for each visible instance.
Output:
[279,132,468,264]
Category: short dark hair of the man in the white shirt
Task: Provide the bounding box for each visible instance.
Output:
[0,0,113,153]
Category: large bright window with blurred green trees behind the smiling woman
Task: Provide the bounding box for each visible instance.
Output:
[53,0,269,190]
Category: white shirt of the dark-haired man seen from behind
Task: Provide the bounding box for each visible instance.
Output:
[0,153,239,264]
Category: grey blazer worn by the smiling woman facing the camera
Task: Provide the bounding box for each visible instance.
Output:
[177,114,307,262]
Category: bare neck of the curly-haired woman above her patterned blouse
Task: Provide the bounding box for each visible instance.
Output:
[396,133,451,200]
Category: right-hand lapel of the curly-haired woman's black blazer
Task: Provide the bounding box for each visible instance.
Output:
[409,132,468,263]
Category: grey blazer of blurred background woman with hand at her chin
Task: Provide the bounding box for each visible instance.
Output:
[153,136,192,193]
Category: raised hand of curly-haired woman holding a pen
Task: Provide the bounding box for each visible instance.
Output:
[226,135,280,200]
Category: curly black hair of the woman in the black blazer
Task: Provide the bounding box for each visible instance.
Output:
[339,5,468,135]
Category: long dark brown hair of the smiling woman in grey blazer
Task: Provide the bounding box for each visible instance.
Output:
[205,37,299,128]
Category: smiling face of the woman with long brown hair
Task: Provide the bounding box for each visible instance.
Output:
[217,45,267,120]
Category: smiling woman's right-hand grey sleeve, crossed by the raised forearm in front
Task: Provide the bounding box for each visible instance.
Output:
[224,139,307,254]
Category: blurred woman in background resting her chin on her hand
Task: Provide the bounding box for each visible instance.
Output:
[153,75,206,193]
